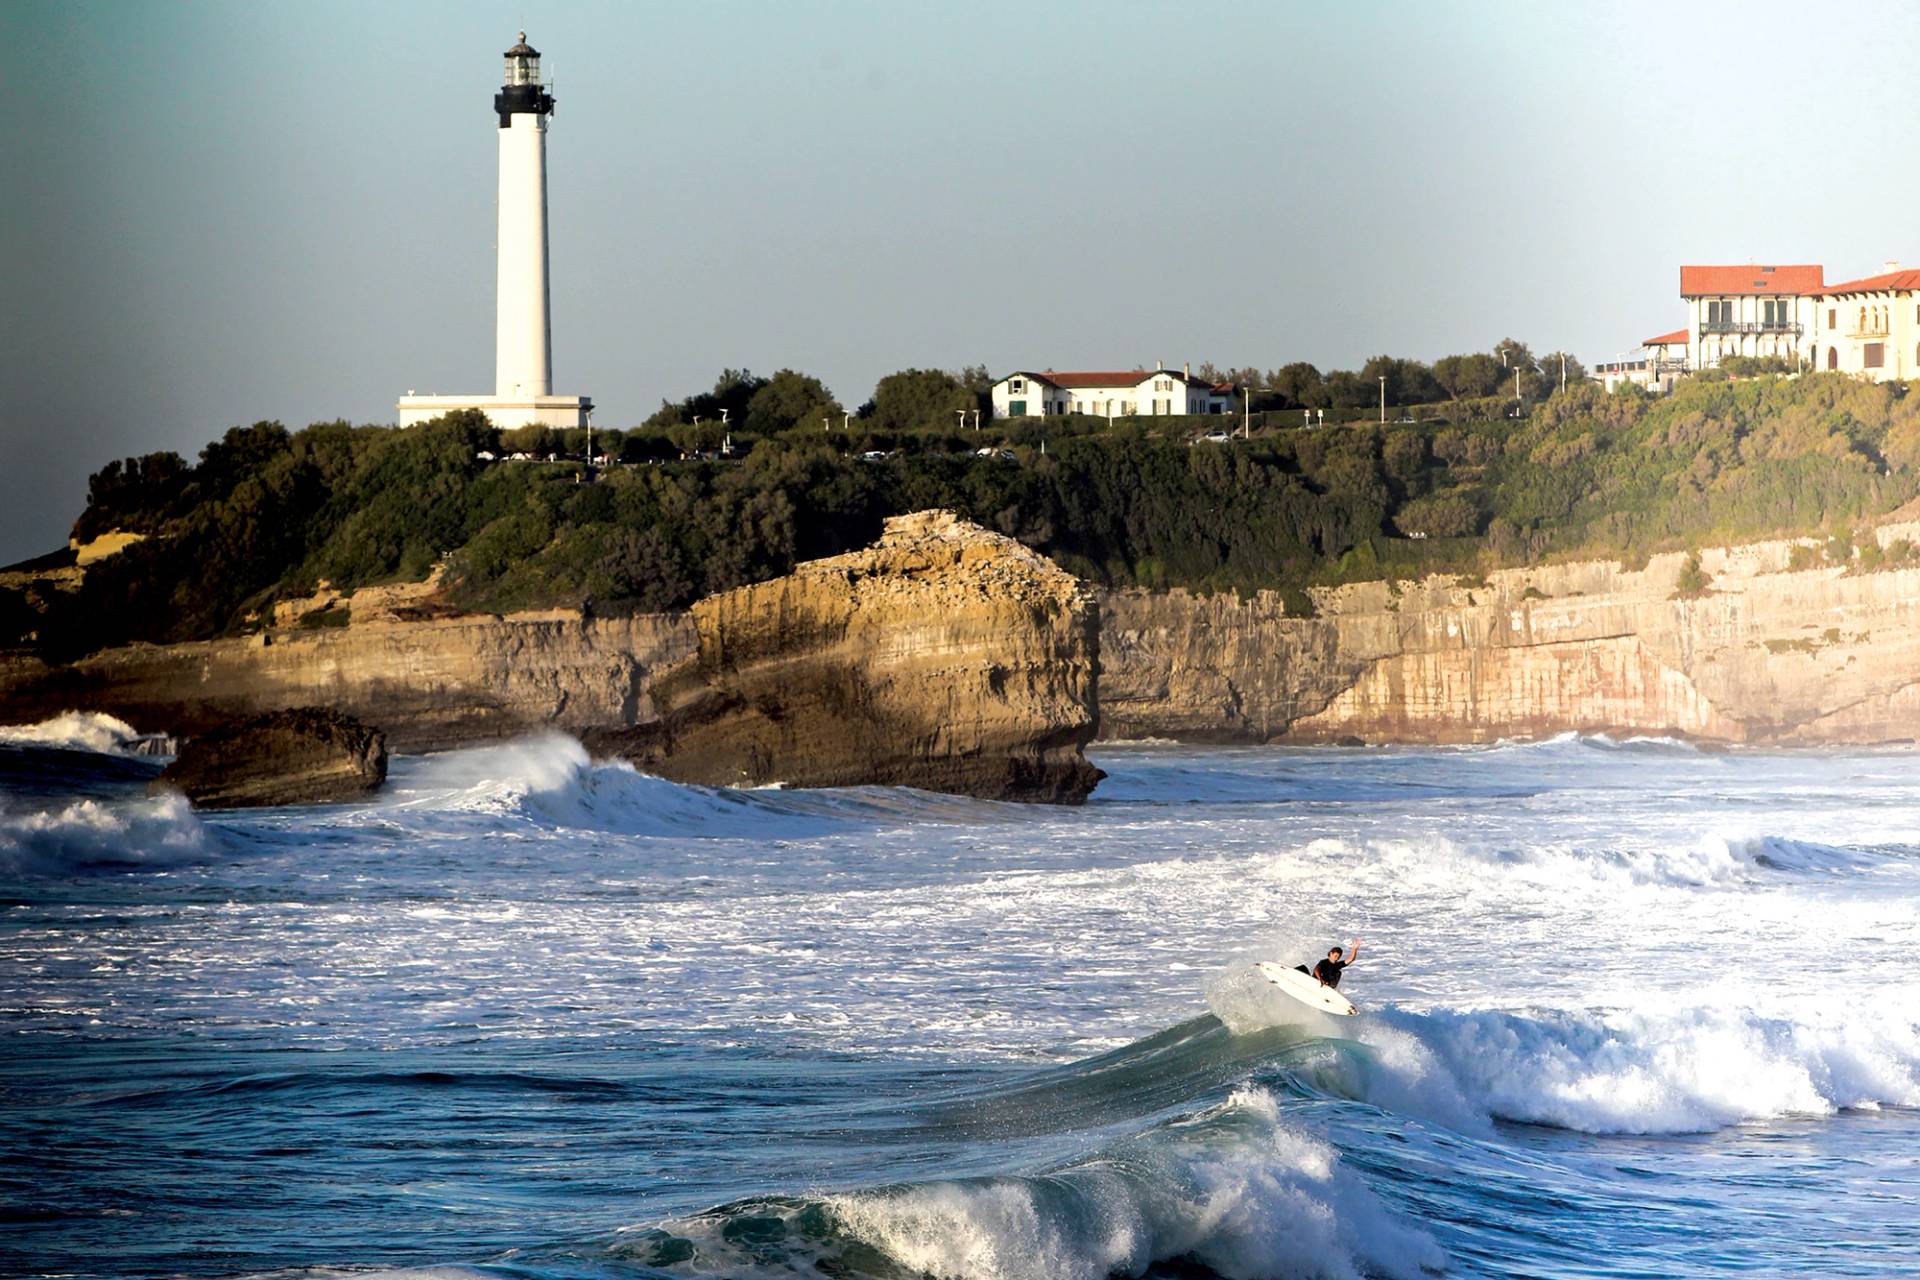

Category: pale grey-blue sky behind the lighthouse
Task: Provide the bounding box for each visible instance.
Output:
[0,0,1920,562]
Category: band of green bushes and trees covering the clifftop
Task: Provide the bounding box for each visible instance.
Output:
[18,370,1920,652]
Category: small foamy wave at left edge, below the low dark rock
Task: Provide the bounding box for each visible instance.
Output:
[0,794,215,875]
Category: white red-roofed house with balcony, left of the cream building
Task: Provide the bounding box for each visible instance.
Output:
[1680,263,1826,368]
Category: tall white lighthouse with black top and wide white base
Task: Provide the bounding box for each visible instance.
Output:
[399,31,593,426]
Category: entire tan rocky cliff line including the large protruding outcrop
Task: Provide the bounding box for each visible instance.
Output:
[0,512,1920,800]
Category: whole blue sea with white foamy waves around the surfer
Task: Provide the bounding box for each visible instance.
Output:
[0,716,1920,1280]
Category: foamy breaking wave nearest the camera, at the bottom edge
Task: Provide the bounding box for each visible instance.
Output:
[645,1086,1446,1280]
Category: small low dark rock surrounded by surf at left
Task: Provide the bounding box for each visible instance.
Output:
[152,706,386,808]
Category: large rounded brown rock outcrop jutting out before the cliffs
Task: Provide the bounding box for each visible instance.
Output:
[588,510,1102,804]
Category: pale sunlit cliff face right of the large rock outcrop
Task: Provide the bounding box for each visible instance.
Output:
[1100,524,1920,743]
